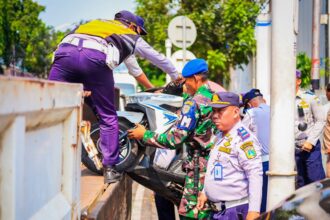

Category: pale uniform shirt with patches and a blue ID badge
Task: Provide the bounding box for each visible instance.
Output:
[204,122,262,212]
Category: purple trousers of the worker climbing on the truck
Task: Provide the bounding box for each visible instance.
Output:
[49,39,119,166]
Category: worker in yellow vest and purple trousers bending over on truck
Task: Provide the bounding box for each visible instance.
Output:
[49,11,178,183]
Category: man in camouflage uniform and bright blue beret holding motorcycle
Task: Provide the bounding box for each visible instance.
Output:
[128,59,215,219]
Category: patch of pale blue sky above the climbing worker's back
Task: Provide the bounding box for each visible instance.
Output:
[35,0,135,29]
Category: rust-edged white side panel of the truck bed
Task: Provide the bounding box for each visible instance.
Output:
[0,77,82,219]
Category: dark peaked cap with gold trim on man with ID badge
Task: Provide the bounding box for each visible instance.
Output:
[210,92,240,108]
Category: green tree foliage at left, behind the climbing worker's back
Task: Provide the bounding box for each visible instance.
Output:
[0,0,63,76]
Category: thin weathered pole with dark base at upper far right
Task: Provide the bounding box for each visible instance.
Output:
[311,0,321,90]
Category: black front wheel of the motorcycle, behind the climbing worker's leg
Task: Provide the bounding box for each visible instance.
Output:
[81,120,139,175]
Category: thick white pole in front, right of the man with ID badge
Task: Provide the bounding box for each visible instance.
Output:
[267,0,296,210]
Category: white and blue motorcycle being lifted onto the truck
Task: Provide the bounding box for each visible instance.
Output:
[82,82,187,205]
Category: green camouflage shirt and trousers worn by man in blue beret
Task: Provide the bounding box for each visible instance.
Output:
[143,84,216,219]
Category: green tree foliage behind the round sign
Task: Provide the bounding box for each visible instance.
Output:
[136,0,260,85]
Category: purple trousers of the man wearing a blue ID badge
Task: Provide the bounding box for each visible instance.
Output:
[212,204,249,220]
